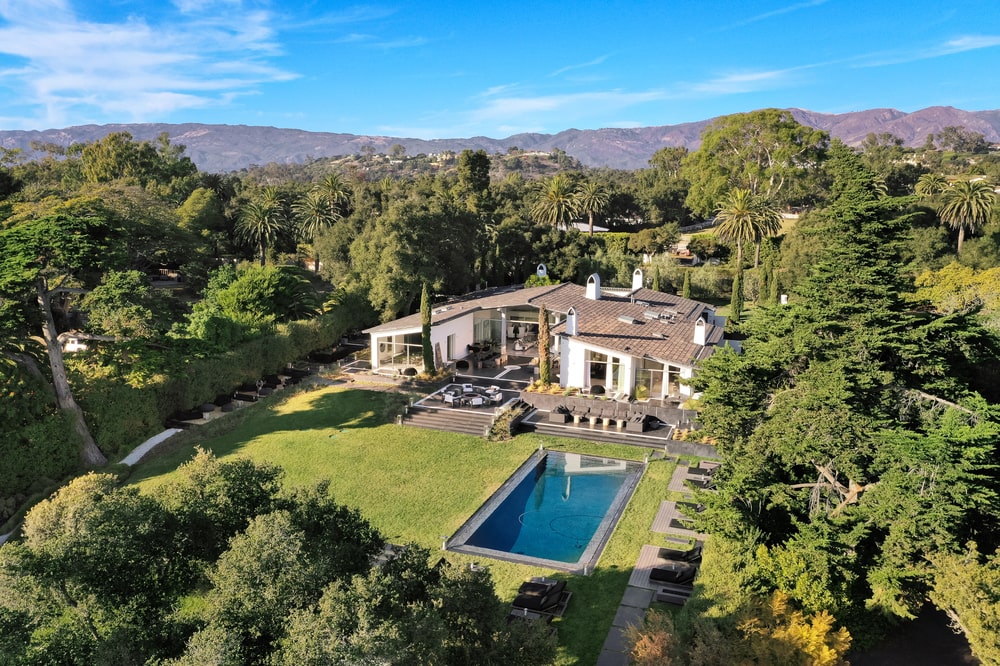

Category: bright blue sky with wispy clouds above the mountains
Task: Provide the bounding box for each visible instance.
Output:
[0,0,1000,138]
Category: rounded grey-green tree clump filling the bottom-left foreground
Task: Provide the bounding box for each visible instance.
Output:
[0,452,554,666]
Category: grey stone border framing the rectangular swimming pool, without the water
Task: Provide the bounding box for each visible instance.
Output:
[444,448,647,576]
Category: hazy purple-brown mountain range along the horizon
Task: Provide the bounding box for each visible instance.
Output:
[0,106,1000,172]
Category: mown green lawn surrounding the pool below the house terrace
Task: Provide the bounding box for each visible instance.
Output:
[131,387,673,664]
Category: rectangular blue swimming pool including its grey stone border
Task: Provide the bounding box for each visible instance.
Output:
[446,451,645,573]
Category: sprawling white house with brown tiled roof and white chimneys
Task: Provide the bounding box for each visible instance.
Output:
[365,266,725,398]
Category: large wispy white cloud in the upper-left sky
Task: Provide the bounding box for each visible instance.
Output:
[0,0,296,126]
